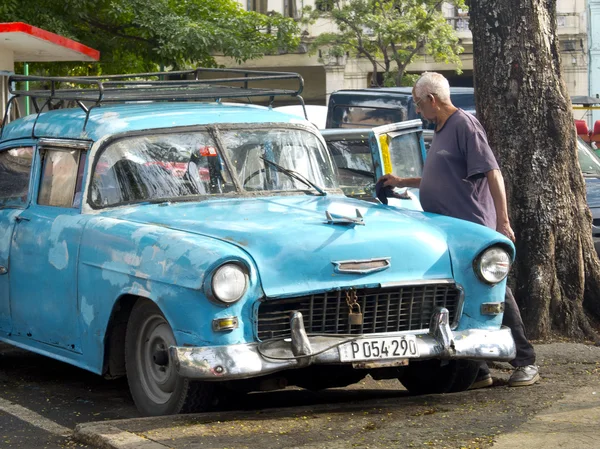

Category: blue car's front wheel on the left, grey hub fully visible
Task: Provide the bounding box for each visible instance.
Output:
[125,299,216,416]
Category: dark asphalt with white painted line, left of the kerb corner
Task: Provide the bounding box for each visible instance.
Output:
[0,343,139,449]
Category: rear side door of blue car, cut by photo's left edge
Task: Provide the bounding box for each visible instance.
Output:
[0,145,34,334]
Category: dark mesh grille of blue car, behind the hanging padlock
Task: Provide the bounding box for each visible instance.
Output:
[258,283,461,340]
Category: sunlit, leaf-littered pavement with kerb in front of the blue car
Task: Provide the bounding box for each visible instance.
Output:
[75,343,600,449]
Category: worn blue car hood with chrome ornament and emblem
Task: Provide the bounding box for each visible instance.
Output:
[102,195,491,297]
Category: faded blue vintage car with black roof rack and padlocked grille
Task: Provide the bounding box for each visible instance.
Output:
[0,70,514,415]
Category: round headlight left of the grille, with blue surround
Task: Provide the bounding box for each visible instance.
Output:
[205,261,249,306]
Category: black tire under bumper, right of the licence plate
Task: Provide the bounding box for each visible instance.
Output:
[398,359,479,394]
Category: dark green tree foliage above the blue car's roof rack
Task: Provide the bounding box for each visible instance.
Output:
[6,0,300,74]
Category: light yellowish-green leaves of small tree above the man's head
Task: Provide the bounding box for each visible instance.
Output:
[303,0,466,85]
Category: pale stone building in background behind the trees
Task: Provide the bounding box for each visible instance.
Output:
[224,0,600,107]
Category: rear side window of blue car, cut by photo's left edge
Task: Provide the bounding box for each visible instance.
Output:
[0,147,33,207]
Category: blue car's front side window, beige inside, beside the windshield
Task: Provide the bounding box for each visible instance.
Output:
[38,150,81,207]
